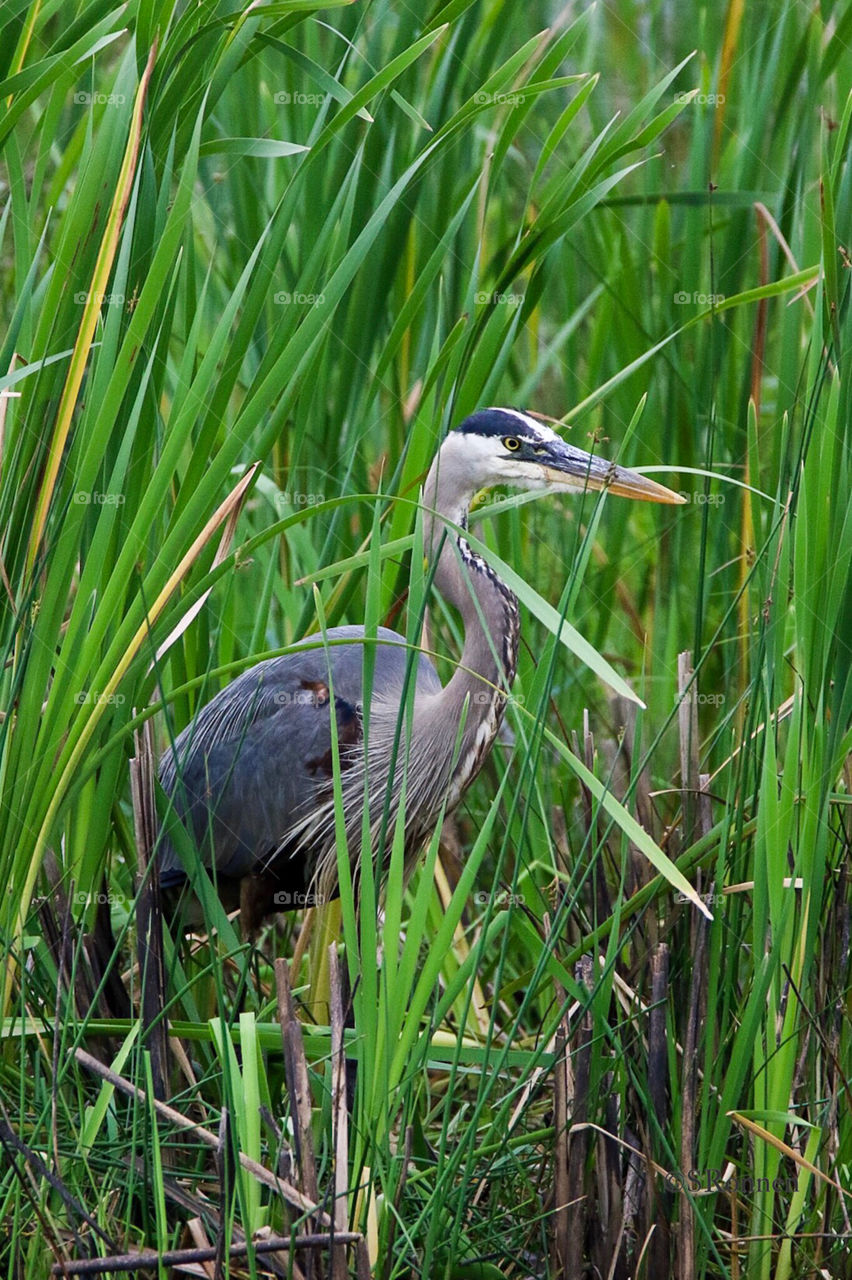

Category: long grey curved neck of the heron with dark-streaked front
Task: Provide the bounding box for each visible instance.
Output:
[423,451,519,782]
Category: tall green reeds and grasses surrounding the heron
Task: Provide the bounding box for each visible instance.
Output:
[0,0,852,1280]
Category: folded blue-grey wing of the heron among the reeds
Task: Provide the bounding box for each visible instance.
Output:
[159,627,441,887]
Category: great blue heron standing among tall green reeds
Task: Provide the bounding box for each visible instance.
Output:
[160,408,684,929]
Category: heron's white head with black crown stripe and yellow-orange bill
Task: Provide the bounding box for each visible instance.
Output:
[445,408,686,503]
